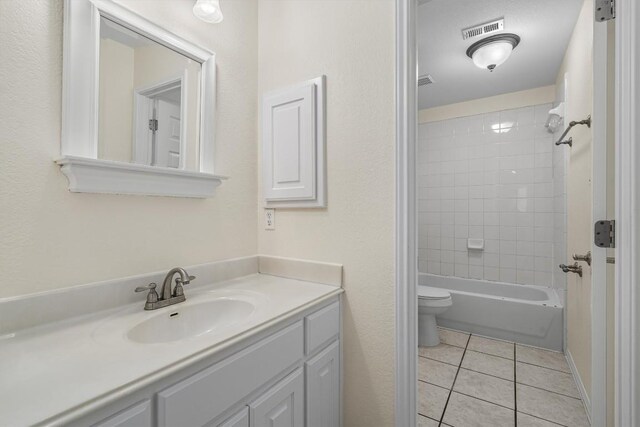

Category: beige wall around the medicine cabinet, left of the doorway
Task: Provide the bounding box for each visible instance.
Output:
[258,0,395,426]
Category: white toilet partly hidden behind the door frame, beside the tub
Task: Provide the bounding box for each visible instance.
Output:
[418,285,452,347]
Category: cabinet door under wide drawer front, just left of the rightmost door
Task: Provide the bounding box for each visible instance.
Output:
[249,368,304,427]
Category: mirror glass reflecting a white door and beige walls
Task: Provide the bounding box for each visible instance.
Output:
[98,17,201,170]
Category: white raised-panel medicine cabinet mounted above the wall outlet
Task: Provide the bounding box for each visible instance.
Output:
[262,77,325,207]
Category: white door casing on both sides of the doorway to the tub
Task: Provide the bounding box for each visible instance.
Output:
[395,0,640,426]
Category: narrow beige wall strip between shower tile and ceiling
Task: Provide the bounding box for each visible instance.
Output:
[418,85,556,123]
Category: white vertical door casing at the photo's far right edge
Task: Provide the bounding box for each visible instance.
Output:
[615,0,640,427]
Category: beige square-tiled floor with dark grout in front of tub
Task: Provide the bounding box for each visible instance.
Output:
[418,328,589,427]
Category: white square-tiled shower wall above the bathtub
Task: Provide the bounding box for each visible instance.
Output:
[418,104,565,287]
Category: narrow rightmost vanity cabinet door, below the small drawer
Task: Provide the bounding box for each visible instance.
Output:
[306,341,340,427]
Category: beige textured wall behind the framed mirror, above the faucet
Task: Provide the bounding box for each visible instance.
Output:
[0,0,260,297]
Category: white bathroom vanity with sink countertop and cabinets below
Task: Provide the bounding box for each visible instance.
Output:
[0,258,342,427]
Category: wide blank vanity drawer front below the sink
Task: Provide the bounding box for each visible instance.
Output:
[158,322,303,427]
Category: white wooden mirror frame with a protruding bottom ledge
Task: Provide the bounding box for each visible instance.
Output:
[56,0,225,198]
